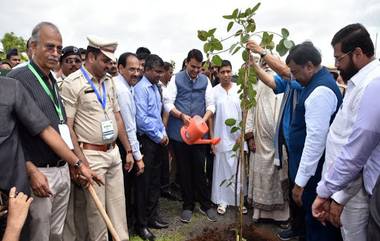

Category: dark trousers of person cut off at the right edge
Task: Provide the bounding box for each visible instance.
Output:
[367,176,380,241]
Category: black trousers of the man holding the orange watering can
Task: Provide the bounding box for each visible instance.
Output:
[171,140,212,210]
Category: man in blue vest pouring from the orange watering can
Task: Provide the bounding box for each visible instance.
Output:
[164,49,216,223]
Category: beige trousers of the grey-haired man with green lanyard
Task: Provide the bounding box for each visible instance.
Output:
[30,164,70,241]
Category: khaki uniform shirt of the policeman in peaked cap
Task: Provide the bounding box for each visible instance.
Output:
[61,67,120,145]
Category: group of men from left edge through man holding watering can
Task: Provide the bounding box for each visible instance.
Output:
[0,22,223,240]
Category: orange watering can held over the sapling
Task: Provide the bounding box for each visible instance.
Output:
[181,115,220,145]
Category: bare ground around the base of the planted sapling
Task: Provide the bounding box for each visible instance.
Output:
[131,198,286,241]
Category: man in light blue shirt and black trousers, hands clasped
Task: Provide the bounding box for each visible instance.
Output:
[134,54,169,240]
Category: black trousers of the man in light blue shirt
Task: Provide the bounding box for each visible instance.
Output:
[134,135,164,227]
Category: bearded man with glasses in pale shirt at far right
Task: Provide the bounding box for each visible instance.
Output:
[313,24,380,241]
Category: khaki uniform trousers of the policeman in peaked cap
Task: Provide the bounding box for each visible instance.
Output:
[83,146,128,241]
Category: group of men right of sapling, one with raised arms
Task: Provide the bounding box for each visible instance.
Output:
[247,24,380,241]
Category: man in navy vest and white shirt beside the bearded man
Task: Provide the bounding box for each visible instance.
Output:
[286,42,342,241]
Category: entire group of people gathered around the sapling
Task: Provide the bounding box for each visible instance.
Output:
[0,19,380,241]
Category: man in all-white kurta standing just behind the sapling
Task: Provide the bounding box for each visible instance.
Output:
[211,60,242,214]
